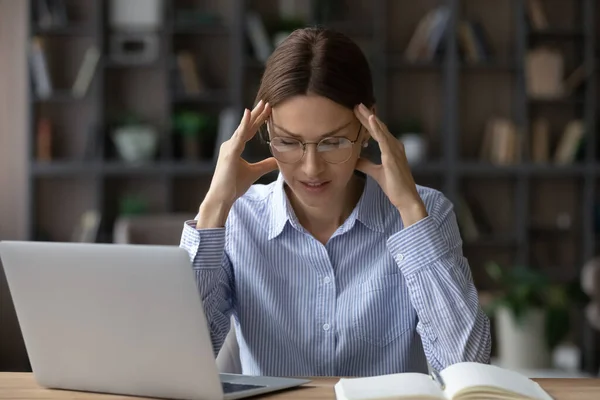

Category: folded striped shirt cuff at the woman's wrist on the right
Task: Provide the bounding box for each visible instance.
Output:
[387,216,449,275]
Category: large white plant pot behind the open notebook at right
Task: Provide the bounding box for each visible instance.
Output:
[496,307,552,370]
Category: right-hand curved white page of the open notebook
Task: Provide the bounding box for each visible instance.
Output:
[440,362,552,400]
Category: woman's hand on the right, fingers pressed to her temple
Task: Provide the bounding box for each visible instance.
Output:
[354,104,427,226]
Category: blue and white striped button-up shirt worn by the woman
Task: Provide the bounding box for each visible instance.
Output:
[180,175,491,376]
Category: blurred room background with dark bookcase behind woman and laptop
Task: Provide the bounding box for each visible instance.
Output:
[0,0,600,382]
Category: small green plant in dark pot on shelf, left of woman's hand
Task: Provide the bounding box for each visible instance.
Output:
[173,111,210,160]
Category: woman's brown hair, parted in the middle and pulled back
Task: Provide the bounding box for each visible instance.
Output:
[255,27,375,138]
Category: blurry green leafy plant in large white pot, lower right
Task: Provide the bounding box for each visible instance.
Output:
[484,262,582,369]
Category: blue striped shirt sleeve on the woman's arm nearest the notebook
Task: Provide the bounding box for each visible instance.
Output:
[388,192,491,370]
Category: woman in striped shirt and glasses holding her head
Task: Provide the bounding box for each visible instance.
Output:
[181,28,490,376]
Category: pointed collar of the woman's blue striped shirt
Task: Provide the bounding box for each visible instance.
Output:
[269,173,385,240]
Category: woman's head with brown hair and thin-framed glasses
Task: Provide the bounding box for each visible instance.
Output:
[256,28,375,207]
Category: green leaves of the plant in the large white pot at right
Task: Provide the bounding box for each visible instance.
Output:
[485,262,585,349]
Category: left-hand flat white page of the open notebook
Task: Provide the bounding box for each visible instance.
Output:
[336,373,445,400]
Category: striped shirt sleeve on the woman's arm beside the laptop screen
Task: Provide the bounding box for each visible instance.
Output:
[180,221,234,357]
